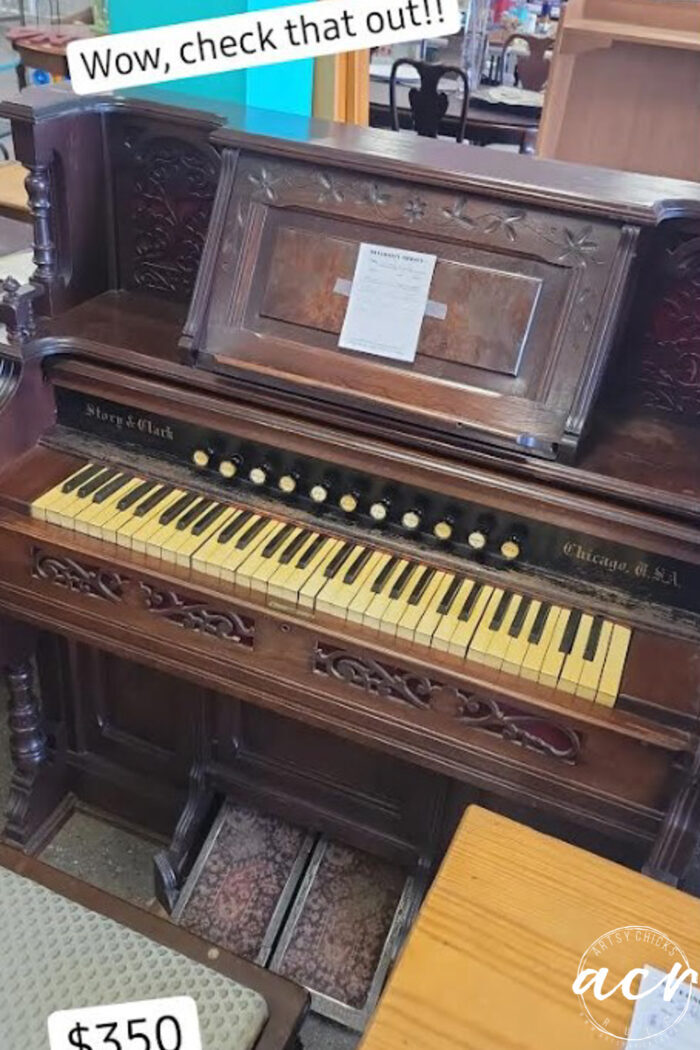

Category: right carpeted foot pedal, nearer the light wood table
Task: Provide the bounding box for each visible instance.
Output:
[270,836,422,1031]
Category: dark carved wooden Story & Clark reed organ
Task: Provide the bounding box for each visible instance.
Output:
[0,87,700,944]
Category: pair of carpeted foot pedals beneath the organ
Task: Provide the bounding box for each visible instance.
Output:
[172,799,422,1031]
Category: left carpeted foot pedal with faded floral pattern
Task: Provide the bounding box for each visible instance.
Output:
[172,799,315,966]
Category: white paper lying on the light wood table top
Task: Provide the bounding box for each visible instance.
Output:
[627,966,700,1050]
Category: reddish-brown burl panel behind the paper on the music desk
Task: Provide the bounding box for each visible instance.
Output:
[260,226,542,376]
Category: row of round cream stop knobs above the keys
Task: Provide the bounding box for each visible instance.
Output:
[192,448,521,562]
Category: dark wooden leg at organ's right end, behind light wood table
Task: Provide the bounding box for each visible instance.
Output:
[644,747,700,886]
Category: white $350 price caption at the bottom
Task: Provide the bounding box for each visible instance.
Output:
[48,995,201,1050]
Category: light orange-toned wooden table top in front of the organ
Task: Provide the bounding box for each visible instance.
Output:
[360,806,700,1050]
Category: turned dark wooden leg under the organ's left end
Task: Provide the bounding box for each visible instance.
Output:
[2,624,65,853]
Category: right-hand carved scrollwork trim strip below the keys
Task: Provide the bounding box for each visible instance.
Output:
[314,643,582,764]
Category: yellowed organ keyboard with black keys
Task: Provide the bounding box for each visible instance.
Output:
[30,463,631,707]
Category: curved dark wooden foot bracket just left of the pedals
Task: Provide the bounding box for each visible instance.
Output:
[153,762,215,911]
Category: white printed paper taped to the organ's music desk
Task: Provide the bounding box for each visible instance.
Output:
[338,244,437,361]
